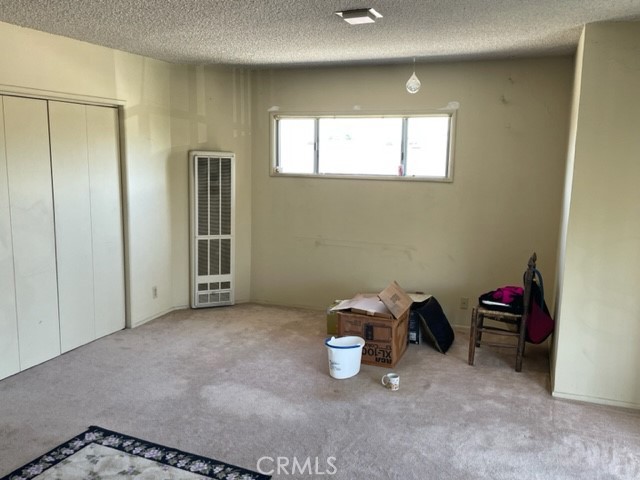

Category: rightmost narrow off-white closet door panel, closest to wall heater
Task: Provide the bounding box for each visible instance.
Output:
[86,106,125,337]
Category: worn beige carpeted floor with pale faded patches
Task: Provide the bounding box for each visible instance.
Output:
[0,304,640,480]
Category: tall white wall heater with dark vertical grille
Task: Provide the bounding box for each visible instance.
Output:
[189,151,235,308]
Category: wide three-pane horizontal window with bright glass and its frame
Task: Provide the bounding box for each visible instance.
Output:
[272,112,454,181]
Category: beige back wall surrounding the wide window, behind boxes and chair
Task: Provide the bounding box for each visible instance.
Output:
[252,57,573,325]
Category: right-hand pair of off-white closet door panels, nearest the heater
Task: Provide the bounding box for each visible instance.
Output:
[49,101,125,352]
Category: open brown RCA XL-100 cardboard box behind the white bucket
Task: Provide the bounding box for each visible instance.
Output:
[332,282,412,368]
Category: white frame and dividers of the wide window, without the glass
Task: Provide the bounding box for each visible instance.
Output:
[269,109,457,183]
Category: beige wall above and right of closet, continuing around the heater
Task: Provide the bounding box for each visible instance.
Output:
[0,23,251,325]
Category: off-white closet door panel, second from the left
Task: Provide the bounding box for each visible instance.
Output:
[4,97,60,370]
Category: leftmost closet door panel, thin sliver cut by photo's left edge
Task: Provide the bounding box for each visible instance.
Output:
[0,97,20,378]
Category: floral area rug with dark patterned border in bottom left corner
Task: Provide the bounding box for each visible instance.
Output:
[0,427,271,480]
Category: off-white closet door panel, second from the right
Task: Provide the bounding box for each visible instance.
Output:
[49,102,96,352]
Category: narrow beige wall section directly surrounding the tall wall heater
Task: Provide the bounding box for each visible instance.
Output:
[169,67,251,306]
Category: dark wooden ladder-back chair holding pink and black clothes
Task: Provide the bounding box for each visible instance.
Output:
[469,252,537,372]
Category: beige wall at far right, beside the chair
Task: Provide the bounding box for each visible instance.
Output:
[553,23,640,408]
